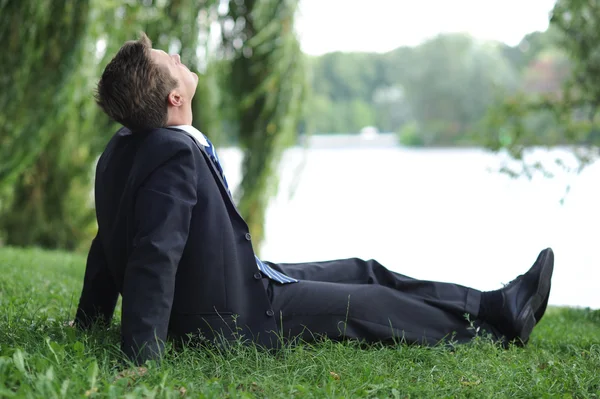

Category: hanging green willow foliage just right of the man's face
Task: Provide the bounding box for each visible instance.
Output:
[222,0,305,251]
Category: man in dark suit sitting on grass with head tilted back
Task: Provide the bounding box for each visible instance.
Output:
[75,35,554,363]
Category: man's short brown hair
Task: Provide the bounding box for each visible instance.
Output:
[95,33,177,131]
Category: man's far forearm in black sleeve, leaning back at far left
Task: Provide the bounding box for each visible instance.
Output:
[75,232,119,329]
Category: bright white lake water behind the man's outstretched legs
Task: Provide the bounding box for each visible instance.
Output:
[219,137,600,308]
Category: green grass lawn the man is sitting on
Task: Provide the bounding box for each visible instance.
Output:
[0,248,600,398]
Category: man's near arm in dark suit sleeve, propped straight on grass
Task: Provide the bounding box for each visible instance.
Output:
[121,148,197,364]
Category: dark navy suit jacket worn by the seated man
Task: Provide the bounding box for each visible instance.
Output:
[75,128,276,363]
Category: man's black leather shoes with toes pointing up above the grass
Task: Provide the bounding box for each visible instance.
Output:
[498,248,554,344]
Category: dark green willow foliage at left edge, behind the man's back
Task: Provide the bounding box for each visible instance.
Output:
[0,0,93,249]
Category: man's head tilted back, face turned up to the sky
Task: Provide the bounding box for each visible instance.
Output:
[96,34,198,131]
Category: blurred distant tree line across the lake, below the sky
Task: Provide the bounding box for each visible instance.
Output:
[303,28,570,146]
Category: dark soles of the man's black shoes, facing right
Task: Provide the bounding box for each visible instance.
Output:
[517,248,554,345]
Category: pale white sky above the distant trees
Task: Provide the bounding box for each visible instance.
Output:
[296,0,555,55]
